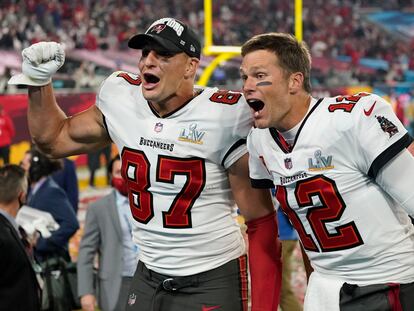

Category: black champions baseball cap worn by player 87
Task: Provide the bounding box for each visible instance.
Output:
[128,17,201,59]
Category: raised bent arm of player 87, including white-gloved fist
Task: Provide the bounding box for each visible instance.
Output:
[9,42,110,157]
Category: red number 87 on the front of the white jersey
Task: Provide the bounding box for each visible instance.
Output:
[121,148,206,229]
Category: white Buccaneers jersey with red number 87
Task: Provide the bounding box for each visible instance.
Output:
[96,72,252,276]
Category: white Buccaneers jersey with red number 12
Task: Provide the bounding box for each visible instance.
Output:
[247,93,414,285]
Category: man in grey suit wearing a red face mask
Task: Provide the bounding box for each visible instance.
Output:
[78,156,138,311]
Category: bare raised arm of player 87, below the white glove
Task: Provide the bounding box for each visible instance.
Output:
[28,83,110,157]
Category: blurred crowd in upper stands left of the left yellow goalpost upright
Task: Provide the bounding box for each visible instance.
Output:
[0,0,203,50]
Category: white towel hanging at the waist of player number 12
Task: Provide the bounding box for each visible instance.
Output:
[304,271,344,311]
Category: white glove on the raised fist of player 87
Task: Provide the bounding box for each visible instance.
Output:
[8,42,65,86]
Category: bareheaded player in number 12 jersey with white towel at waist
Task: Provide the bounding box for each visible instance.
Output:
[240,33,414,311]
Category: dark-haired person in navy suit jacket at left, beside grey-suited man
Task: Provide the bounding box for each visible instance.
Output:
[22,148,79,262]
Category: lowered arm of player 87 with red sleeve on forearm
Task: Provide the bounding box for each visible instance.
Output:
[228,154,282,311]
